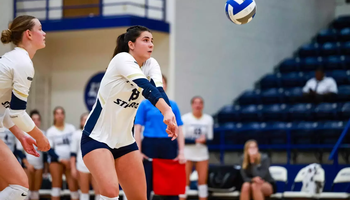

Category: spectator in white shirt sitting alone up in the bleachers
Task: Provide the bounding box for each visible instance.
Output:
[303,68,338,103]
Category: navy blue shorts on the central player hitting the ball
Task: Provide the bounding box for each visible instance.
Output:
[81,134,139,159]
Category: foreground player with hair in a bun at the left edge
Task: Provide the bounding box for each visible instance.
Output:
[0,15,50,200]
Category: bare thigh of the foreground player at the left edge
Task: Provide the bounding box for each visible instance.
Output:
[0,140,29,188]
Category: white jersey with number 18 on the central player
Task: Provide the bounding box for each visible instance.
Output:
[83,53,163,148]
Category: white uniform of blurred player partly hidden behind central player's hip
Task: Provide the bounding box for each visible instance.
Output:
[70,129,90,173]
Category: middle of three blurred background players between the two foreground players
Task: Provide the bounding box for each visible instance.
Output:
[46,106,79,200]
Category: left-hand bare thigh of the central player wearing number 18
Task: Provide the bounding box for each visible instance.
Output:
[83,148,120,197]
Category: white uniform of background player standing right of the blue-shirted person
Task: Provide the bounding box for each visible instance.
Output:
[182,113,214,161]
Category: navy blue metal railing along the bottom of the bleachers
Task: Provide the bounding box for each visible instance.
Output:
[208,125,350,164]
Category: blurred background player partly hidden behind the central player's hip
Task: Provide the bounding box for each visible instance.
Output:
[70,113,100,200]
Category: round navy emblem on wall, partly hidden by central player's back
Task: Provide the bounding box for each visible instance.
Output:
[84,72,105,111]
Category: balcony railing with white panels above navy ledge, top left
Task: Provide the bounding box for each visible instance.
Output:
[13,0,166,21]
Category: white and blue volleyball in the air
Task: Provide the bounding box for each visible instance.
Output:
[225,0,256,24]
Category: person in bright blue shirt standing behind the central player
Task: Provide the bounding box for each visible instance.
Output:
[134,75,186,200]
